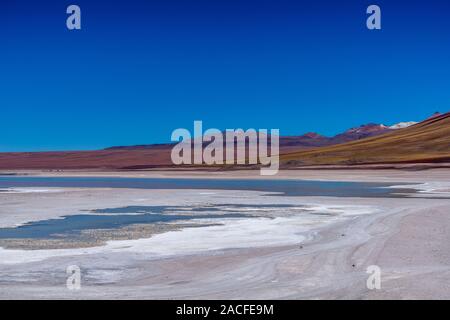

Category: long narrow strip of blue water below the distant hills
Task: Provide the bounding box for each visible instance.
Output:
[0,176,415,198]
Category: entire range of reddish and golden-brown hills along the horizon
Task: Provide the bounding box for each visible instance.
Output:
[0,113,450,170]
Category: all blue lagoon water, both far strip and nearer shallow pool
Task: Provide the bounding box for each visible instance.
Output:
[0,176,414,239]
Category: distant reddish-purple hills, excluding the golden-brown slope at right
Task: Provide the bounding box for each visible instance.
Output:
[0,126,394,170]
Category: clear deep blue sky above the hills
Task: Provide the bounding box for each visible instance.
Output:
[0,0,450,151]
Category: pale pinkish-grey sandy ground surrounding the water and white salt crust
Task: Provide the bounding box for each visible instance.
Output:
[0,169,450,299]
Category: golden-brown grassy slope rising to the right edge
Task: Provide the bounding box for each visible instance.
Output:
[281,113,450,166]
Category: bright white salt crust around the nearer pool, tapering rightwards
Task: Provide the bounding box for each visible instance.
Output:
[0,189,376,264]
